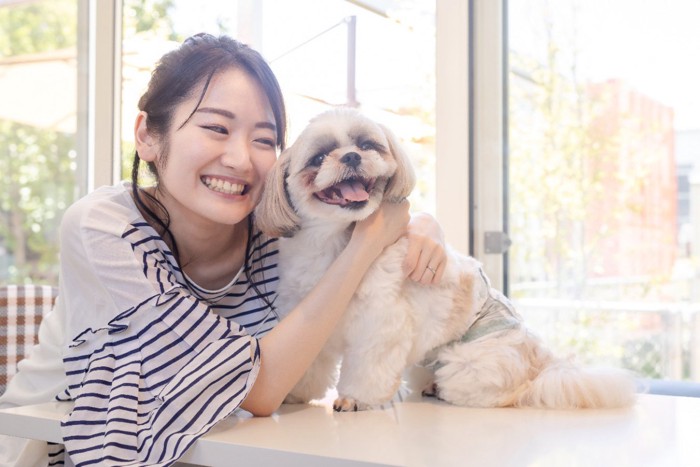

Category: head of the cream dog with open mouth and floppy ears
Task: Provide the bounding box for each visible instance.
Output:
[256,108,414,236]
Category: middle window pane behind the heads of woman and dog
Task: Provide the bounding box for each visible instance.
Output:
[122,0,435,212]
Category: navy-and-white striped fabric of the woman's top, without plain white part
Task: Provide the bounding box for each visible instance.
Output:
[61,223,278,466]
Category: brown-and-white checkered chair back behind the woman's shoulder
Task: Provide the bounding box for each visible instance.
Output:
[0,285,58,394]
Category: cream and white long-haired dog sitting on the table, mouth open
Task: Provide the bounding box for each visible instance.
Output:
[255,108,636,411]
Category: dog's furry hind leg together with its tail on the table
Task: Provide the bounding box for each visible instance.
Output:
[435,329,637,409]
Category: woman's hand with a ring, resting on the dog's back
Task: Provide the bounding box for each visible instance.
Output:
[403,213,447,284]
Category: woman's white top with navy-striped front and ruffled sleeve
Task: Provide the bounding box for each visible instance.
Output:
[0,183,278,466]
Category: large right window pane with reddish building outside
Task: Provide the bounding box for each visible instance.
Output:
[508,0,700,379]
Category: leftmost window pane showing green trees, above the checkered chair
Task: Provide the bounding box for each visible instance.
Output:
[0,0,81,285]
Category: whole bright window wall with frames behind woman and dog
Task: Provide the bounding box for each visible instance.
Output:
[0,0,700,379]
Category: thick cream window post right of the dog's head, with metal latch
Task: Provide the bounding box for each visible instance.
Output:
[436,0,508,290]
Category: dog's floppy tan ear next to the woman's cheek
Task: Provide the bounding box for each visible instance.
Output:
[255,147,300,237]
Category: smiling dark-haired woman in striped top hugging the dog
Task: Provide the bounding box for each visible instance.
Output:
[0,34,444,465]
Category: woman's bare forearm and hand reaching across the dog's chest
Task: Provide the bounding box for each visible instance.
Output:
[242,201,409,415]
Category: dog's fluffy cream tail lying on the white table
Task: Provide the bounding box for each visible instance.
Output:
[514,359,637,409]
